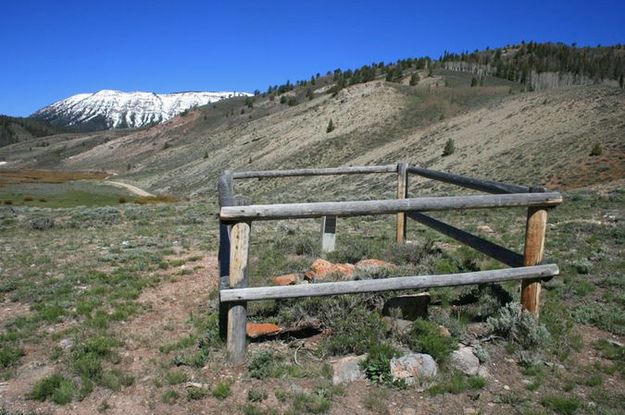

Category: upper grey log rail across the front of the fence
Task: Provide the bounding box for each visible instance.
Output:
[219,192,562,221]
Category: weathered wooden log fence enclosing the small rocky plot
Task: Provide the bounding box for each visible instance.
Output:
[218,163,562,364]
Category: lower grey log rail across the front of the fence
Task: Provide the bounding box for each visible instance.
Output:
[220,264,559,302]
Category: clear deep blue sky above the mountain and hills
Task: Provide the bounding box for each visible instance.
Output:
[0,0,625,116]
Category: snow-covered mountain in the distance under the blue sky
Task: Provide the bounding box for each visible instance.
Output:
[32,89,251,130]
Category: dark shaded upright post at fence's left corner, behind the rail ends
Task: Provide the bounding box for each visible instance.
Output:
[217,170,236,340]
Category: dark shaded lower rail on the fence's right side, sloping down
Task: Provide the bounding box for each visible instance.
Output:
[408,212,524,267]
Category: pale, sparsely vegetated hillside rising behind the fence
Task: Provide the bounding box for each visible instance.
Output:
[6,70,625,202]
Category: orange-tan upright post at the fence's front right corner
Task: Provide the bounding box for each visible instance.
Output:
[521,187,547,317]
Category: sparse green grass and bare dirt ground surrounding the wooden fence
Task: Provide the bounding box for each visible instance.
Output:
[0,183,625,415]
